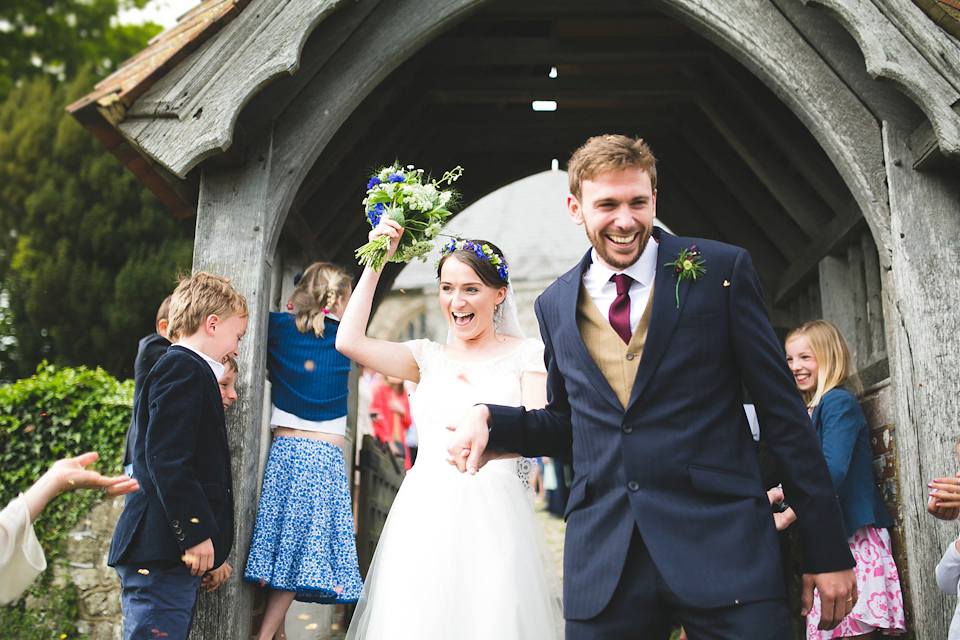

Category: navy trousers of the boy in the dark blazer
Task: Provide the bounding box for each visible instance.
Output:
[116,564,201,640]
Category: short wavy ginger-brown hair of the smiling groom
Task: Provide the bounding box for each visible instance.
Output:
[567,135,657,200]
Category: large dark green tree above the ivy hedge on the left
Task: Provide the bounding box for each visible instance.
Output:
[0,71,192,380]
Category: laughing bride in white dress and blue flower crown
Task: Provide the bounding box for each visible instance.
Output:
[337,216,563,640]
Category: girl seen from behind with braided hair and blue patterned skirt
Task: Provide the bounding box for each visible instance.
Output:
[244,262,362,640]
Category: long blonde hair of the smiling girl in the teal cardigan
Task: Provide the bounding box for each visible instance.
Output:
[783,320,863,408]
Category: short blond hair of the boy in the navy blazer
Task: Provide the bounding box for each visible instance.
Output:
[167,271,248,342]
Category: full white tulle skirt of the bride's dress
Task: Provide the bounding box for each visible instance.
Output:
[347,459,563,640]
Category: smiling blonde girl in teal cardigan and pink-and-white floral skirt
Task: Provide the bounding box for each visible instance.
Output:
[785,320,905,640]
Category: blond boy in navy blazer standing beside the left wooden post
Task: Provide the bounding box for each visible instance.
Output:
[107,272,247,640]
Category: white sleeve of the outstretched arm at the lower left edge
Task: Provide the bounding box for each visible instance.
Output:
[0,493,47,604]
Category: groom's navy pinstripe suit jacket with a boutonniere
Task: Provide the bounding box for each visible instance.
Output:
[488,229,854,619]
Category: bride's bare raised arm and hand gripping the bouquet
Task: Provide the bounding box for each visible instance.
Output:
[337,216,420,382]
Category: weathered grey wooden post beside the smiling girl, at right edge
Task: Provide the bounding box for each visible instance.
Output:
[883,122,960,638]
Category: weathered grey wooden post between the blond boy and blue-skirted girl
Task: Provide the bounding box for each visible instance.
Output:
[190,131,280,640]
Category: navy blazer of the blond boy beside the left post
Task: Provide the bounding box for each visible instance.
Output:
[107,345,233,567]
